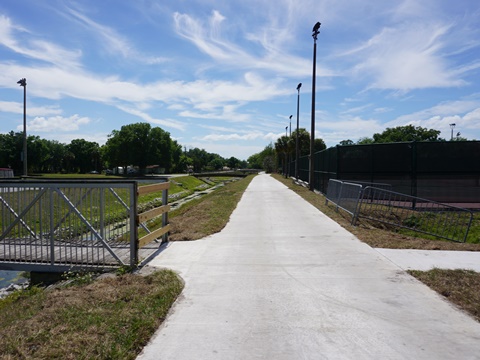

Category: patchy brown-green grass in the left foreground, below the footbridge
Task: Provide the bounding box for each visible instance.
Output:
[0,270,183,359]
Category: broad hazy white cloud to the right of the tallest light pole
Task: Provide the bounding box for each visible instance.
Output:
[350,24,466,91]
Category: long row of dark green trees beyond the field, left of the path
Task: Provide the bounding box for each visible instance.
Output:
[0,123,247,175]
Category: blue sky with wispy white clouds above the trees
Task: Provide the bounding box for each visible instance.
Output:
[0,0,480,160]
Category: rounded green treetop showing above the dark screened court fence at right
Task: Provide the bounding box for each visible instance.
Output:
[373,125,443,143]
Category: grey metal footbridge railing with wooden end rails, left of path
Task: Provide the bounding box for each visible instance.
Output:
[0,180,169,272]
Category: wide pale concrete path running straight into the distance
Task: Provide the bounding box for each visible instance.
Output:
[139,175,480,360]
